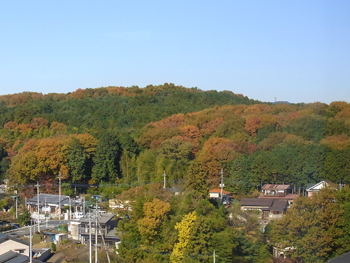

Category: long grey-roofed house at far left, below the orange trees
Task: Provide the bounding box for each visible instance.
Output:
[27,194,83,220]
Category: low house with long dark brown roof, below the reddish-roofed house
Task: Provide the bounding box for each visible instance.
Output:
[241,198,288,220]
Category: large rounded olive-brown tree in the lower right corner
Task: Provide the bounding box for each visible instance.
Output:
[269,188,344,263]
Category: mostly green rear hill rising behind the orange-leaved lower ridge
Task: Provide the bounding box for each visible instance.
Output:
[0,83,258,132]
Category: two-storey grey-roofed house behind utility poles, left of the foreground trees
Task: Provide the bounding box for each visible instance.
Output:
[68,213,120,246]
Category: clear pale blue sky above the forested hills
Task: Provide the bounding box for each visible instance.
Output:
[0,0,350,103]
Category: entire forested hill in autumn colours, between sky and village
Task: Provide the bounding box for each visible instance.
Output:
[0,84,350,201]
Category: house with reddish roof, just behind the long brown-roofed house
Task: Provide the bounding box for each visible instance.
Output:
[259,184,299,205]
